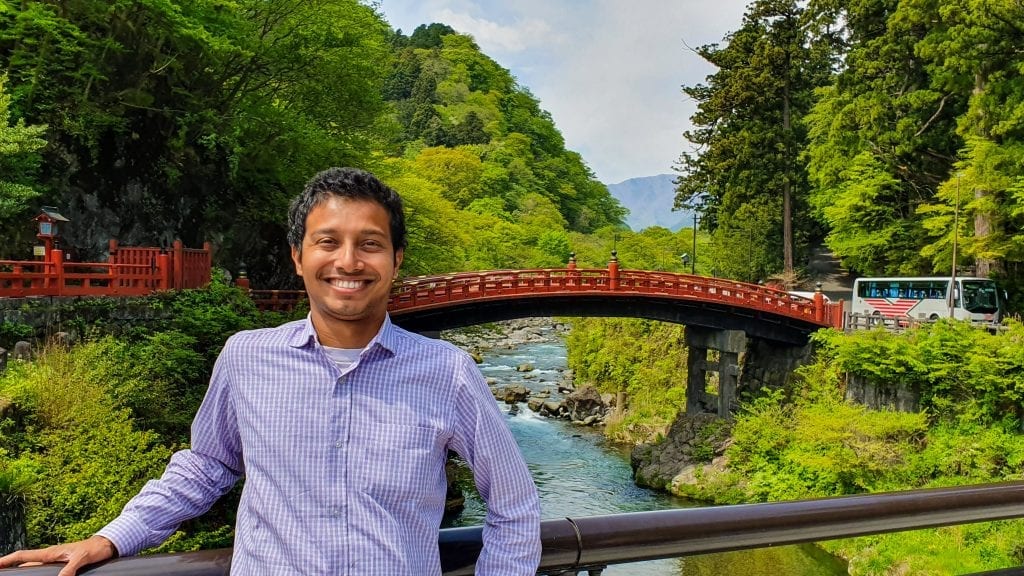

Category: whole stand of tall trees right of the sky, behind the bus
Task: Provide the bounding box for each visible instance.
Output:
[677,0,1024,295]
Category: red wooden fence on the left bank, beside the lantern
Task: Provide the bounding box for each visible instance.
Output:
[0,240,212,297]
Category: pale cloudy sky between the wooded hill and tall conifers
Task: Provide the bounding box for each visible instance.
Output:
[380,0,748,184]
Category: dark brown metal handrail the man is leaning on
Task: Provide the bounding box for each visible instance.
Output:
[4,482,1024,576]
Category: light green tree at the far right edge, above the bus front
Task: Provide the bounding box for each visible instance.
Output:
[918,0,1024,276]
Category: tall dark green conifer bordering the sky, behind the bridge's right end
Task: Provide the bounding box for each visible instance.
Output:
[676,0,830,273]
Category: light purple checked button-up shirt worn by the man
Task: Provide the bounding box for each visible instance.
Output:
[98,319,541,576]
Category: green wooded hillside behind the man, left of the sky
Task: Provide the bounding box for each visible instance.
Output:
[0,0,625,288]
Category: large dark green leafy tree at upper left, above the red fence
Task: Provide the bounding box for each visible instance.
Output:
[0,0,390,283]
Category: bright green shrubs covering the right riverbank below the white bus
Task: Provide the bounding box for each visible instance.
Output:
[677,321,1024,574]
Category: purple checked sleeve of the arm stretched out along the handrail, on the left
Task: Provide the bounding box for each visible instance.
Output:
[97,345,243,557]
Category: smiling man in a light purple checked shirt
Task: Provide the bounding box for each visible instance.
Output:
[0,168,541,576]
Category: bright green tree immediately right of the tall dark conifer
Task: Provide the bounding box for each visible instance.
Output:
[806,1,965,275]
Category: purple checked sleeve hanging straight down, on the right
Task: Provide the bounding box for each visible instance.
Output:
[452,356,541,576]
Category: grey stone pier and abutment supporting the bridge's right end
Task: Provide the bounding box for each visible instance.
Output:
[686,326,812,418]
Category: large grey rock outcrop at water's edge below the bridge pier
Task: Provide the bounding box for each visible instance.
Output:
[630,413,732,490]
